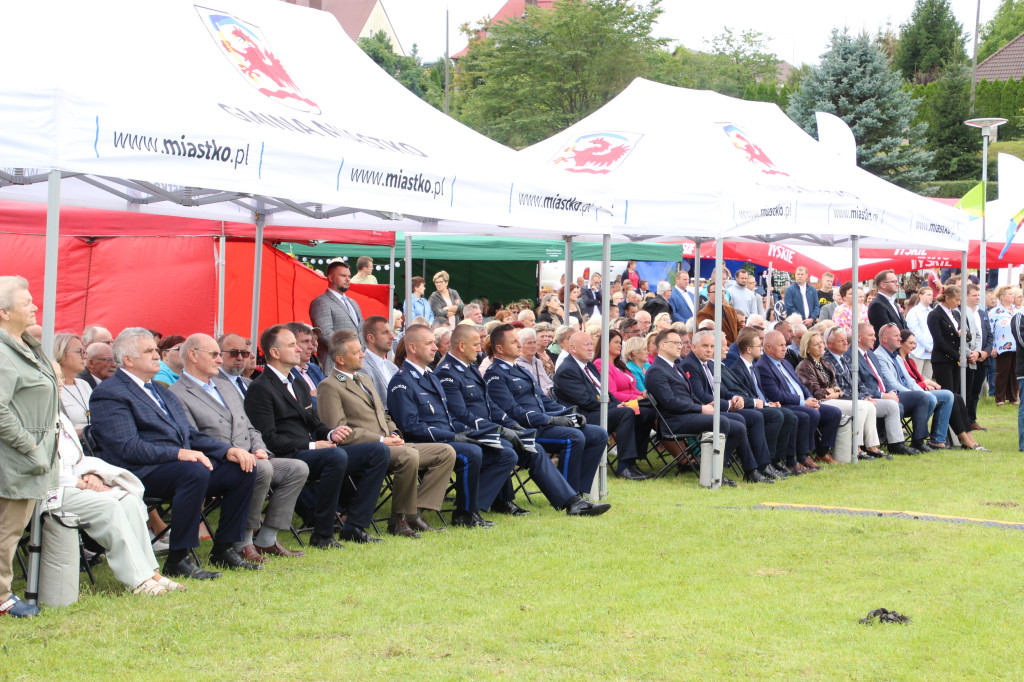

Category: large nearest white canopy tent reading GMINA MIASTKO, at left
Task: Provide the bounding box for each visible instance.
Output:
[0,0,608,348]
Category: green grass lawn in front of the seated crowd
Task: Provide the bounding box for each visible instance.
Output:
[0,398,1024,680]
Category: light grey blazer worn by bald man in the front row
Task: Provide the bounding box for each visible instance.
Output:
[168,368,272,456]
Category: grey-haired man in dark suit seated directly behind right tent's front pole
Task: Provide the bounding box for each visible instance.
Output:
[680,330,781,483]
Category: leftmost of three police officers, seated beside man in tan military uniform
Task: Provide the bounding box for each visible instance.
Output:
[387,325,516,527]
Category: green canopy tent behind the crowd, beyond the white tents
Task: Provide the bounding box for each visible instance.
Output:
[278,232,682,302]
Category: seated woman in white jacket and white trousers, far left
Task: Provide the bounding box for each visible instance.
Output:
[47,364,185,596]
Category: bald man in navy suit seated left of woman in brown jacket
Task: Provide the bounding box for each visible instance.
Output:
[755,331,843,462]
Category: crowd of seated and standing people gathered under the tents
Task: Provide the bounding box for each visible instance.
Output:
[0,263,991,615]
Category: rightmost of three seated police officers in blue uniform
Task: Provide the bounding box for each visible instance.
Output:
[483,325,608,493]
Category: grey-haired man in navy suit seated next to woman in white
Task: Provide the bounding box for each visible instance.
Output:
[89,327,262,580]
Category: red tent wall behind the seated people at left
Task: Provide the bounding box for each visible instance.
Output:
[0,235,388,337]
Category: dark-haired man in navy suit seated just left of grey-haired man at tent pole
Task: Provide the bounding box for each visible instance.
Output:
[644,329,754,485]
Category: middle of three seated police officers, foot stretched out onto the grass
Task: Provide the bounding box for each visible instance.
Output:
[434,325,611,516]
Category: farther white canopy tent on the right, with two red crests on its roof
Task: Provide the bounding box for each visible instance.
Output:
[520,79,967,487]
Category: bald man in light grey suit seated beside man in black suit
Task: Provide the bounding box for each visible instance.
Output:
[170,334,309,563]
